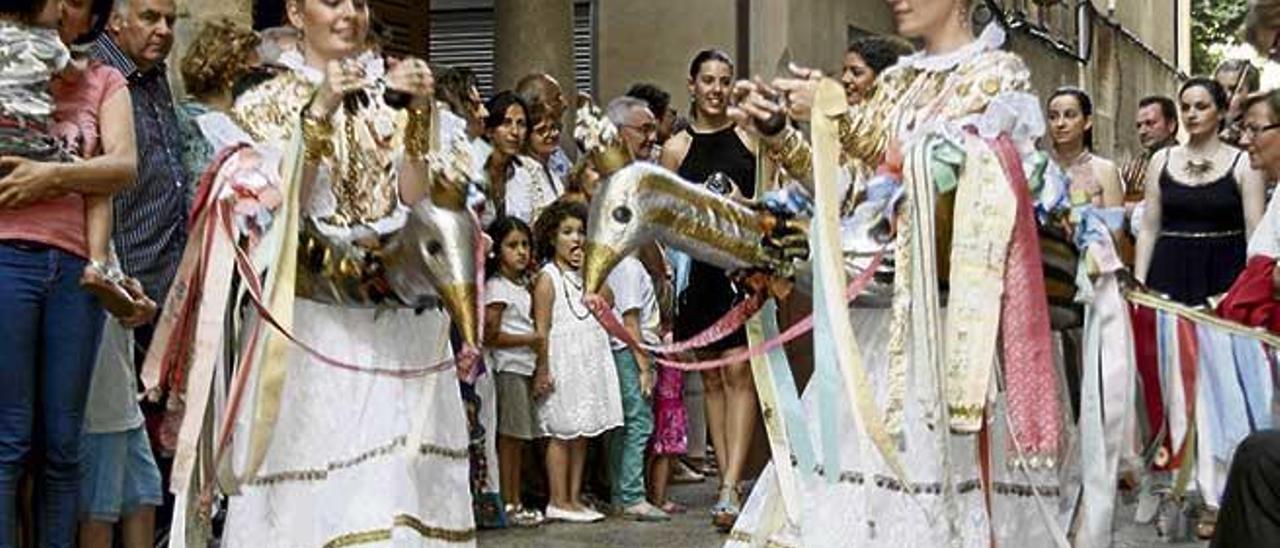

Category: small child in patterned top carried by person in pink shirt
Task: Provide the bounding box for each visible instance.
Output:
[0,12,142,318]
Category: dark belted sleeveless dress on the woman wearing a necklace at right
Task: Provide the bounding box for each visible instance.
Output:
[1147,152,1245,305]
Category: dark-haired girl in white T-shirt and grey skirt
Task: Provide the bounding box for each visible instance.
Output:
[484,216,543,528]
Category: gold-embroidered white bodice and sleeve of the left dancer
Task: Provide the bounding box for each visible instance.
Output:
[233,70,407,227]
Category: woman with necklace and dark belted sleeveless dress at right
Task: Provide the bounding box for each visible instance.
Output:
[1134,78,1266,305]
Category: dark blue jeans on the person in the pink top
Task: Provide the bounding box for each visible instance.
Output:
[0,242,104,547]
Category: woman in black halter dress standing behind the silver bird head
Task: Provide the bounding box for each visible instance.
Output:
[662,50,759,531]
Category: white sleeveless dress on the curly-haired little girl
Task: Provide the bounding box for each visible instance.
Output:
[536,262,622,439]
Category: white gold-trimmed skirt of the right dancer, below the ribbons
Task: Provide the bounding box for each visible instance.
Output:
[726,309,1066,548]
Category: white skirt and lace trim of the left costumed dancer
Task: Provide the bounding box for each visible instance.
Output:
[221,49,476,548]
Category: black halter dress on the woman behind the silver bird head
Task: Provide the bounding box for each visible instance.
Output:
[675,125,755,352]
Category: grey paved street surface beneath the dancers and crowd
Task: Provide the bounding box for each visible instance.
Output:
[479,481,1207,548]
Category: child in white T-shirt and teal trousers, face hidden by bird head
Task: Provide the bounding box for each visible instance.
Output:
[609,250,671,521]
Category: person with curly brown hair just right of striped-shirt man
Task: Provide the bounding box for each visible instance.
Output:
[178,19,262,177]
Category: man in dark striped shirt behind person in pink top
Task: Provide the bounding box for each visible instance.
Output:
[93,0,192,316]
